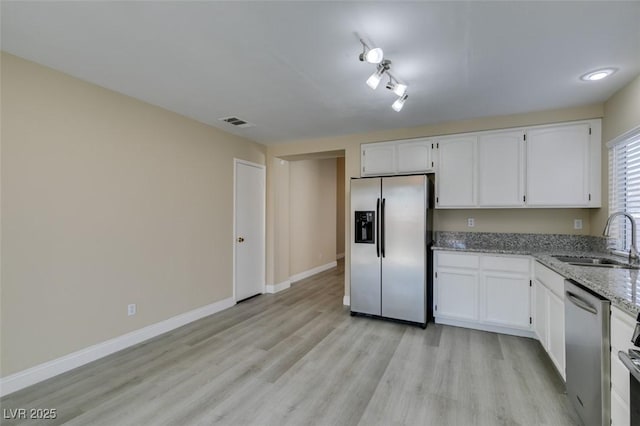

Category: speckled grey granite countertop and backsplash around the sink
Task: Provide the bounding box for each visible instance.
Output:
[432,232,640,318]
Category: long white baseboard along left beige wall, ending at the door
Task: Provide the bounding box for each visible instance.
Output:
[0,297,235,396]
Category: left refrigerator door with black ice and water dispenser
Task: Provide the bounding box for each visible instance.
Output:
[350,178,381,315]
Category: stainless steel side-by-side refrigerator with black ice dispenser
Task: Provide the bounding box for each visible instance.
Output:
[350,175,433,327]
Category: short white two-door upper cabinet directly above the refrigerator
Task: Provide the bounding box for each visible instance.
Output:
[360,139,434,176]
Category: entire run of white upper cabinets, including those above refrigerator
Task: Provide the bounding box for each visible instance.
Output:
[360,119,602,209]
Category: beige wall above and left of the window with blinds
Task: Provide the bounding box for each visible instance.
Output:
[591,75,640,235]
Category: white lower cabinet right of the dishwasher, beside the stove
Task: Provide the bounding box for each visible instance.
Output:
[611,306,636,426]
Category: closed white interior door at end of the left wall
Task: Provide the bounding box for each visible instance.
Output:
[234,159,266,301]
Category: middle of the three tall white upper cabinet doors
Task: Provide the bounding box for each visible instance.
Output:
[478,130,525,207]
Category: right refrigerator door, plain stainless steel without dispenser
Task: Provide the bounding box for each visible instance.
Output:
[380,176,427,323]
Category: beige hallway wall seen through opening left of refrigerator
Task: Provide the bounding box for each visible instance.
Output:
[289,158,337,275]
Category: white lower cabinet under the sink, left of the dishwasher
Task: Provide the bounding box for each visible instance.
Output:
[533,262,566,379]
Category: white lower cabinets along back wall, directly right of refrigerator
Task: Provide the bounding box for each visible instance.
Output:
[434,251,532,336]
